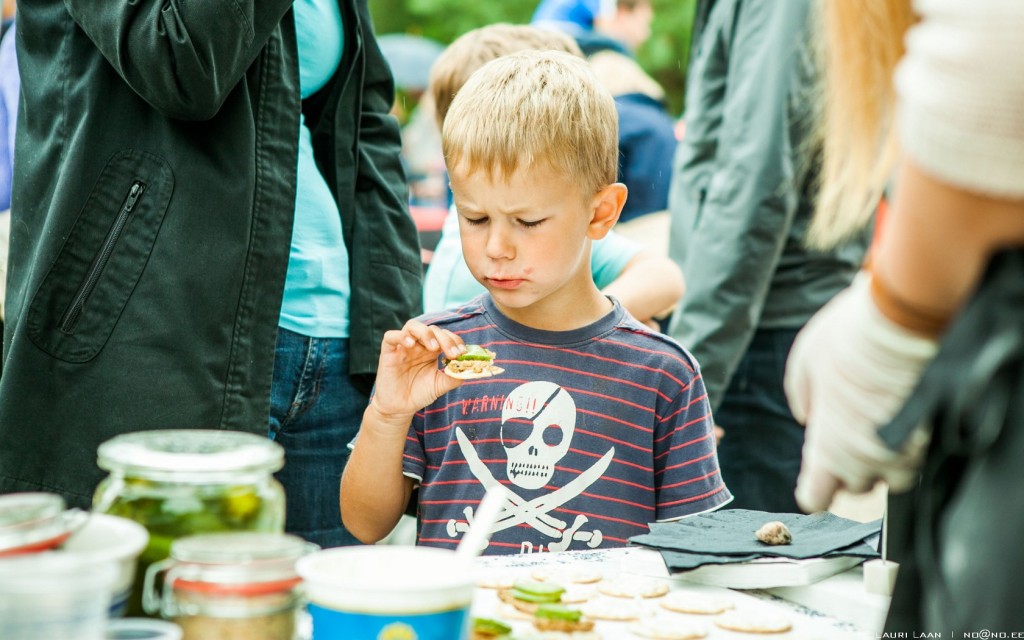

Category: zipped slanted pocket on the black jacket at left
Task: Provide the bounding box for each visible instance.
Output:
[28,150,174,362]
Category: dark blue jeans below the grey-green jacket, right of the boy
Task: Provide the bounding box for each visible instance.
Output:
[715,329,804,513]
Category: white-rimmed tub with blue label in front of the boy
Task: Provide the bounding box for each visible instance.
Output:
[296,545,475,640]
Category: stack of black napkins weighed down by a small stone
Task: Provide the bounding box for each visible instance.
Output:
[630,509,882,570]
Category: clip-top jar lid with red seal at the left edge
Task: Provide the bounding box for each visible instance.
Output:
[0,492,88,557]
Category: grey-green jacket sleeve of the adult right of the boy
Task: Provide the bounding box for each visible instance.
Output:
[670,0,807,409]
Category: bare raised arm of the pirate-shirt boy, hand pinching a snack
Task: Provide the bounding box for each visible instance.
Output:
[341,321,465,544]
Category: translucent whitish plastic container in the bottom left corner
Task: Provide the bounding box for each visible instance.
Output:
[0,552,117,640]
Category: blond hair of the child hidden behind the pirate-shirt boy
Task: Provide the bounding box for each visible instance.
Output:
[427,23,583,128]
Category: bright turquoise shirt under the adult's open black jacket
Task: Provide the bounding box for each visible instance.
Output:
[280,0,351,338]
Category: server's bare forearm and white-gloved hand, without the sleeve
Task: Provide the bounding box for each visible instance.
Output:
[785,159,1024,511]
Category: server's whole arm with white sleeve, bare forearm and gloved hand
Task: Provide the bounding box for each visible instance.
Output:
[785,2,1024,510]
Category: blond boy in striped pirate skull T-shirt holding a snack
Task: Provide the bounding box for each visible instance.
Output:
[342,51,731,553]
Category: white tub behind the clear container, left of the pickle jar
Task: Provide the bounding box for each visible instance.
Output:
[58,513,150,617]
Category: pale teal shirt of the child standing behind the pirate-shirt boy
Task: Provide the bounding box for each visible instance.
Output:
[423,207,640,313]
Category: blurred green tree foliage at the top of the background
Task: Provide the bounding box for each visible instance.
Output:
[370,0,696,117]
